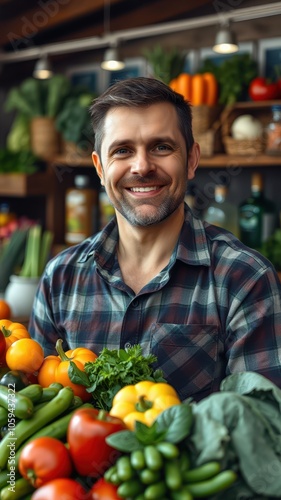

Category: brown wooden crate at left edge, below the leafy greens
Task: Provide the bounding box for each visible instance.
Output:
[0,172,52,197]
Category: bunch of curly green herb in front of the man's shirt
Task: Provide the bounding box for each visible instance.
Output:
[69,345,165,411]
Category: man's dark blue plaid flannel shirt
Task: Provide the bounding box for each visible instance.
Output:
[29,206,281,401]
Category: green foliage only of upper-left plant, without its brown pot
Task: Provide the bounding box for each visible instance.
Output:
[5,74,95,152]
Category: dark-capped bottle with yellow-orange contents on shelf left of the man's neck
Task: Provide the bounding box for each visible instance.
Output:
[65,175,98,245]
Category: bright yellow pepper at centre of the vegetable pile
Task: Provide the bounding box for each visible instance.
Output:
[109,380,181,430]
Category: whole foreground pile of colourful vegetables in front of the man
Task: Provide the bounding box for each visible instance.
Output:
[0,319,281,500]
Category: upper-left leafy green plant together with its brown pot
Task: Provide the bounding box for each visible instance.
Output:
[5,74,93,159]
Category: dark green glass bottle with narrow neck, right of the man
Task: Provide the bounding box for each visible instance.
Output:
[239,173,277,249]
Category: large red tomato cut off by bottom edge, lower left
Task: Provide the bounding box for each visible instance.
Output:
[31,478,88,500]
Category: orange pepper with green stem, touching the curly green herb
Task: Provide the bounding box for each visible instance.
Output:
[38,339,97,401]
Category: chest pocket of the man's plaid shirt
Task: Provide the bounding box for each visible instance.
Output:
[151,323,219,401]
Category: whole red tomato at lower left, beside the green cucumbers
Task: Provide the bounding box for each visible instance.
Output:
[19,436,72,488]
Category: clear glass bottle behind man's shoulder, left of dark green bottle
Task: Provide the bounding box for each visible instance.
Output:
[203,184,238,236]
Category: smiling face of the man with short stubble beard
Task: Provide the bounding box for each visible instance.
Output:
[93,103,197,226]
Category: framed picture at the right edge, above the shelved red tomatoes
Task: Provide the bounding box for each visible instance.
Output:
[259,37,281,80]
